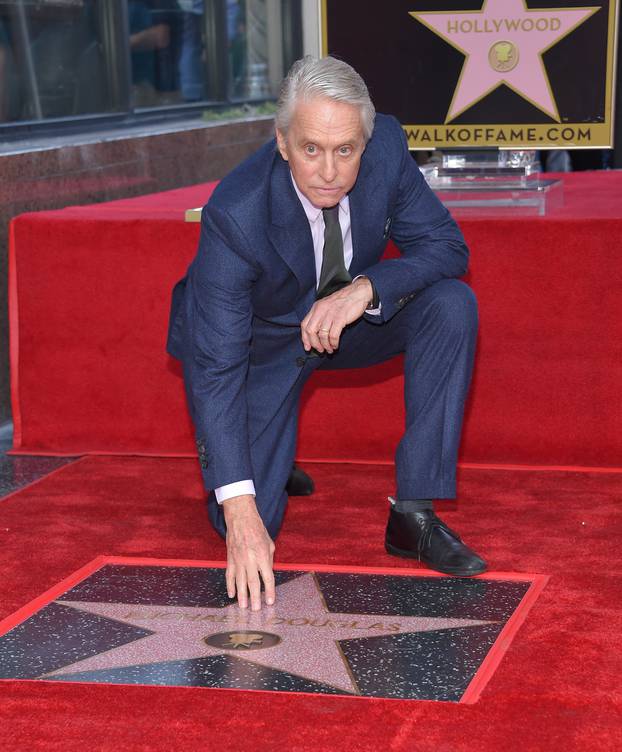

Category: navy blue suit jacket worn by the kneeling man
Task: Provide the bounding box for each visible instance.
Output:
[168,110,468,488]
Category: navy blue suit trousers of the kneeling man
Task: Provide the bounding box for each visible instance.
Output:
[208,279,478,538]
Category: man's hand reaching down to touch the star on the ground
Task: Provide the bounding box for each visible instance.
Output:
[223,495,275,611]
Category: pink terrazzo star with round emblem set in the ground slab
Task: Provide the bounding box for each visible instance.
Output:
[39,573,491,694]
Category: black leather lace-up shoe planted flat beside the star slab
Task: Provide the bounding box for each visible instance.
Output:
[384,509,486,577]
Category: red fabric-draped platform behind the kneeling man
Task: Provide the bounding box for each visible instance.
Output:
[10,172,622,466]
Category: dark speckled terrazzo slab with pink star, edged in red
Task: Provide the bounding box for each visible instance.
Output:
[0,557,546,702]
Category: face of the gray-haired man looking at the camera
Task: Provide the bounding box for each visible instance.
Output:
[276,97,365,209]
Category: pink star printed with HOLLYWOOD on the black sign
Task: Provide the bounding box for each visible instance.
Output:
[410,0,600,122]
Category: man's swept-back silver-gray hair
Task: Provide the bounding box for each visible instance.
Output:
[275,55,376,142]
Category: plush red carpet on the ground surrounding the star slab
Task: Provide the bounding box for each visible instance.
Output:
[0,457,622,752]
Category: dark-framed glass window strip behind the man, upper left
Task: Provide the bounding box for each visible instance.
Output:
[0,0,301,124]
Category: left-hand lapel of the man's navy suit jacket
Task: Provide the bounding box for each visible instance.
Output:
[269,154,316,319]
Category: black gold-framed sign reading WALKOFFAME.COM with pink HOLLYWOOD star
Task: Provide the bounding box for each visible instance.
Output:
[322,0,617,149]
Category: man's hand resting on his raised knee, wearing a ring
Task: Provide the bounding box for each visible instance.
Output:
[300,277,374,353]
